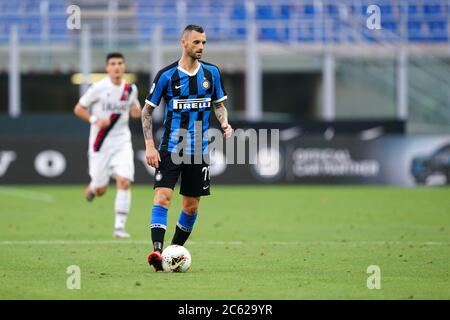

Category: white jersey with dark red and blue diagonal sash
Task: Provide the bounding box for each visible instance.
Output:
[80,77,139,152]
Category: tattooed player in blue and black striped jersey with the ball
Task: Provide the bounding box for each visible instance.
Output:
[142,25,232,271]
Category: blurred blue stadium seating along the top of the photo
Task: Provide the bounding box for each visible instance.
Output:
[0,0,449,43]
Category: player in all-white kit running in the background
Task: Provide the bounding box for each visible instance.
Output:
[74,53,141,238]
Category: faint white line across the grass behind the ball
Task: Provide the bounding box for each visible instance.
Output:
[0,240,450,246]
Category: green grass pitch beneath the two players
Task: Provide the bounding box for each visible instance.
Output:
[0,186,450,299]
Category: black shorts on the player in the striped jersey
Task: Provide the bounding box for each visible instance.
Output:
[153,151,210,197]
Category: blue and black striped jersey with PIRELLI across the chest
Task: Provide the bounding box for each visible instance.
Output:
[145,61,227,154]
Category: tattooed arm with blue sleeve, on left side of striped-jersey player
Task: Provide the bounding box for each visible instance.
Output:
[141,71,167,168]
